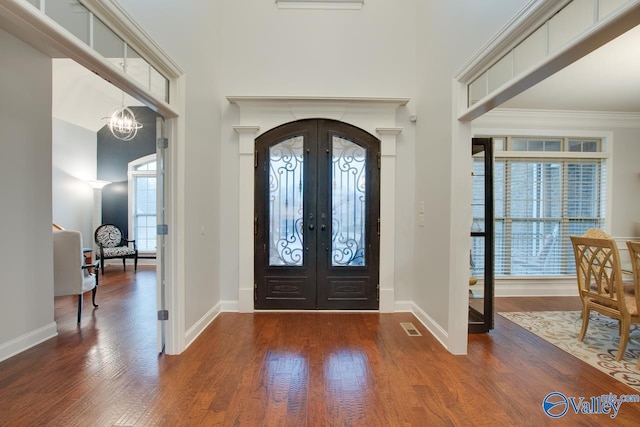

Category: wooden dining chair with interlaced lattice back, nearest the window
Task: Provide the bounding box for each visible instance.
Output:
[571,236,640,360]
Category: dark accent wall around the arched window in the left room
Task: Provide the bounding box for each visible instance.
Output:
[94,107,158,241]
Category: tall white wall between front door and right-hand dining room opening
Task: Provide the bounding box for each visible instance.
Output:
[412,0,527,346]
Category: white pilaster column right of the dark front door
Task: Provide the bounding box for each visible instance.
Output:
[376,128,402,313]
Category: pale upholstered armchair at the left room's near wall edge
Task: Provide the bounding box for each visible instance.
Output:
[53,230,98,323]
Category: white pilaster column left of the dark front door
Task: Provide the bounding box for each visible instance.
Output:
[233,126,260,313]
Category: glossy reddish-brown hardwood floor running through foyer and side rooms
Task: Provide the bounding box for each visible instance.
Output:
[0,266,640,426]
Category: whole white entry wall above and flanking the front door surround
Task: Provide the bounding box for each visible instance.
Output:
[221,0,416,301]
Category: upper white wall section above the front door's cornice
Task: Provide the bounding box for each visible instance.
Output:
[222,0,416,97]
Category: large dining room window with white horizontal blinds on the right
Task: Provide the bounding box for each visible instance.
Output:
[472,137,607,276]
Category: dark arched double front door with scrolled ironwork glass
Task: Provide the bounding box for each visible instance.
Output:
[254,119,380,310]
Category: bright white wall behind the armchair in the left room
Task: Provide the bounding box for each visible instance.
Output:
[52,118,96,242]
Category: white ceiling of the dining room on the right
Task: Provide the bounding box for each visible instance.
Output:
[500,26,640,113]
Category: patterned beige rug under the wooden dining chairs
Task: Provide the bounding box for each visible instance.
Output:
[498,311,640,392]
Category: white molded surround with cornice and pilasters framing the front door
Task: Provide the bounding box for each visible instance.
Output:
[227,97,409,313]
